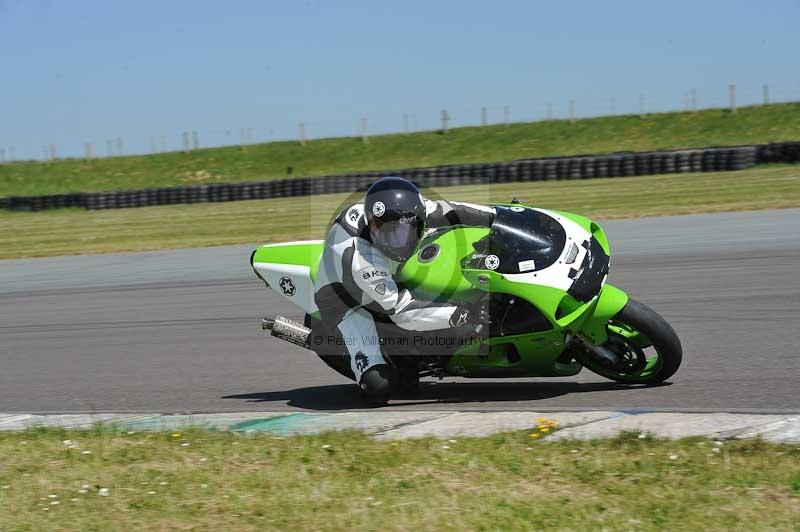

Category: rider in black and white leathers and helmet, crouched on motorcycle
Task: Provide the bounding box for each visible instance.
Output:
[314,177,495,403]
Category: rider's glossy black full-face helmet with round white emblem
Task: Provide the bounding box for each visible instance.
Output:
[364,177,425,262]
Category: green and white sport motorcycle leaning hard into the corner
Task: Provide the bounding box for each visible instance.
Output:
[250,200,682,402]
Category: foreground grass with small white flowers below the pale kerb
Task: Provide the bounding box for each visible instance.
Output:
[0,430,800,530]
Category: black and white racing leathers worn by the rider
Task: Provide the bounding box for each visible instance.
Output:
[314,200,495,383]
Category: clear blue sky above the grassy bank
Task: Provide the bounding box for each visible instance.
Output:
[0,0,800,159]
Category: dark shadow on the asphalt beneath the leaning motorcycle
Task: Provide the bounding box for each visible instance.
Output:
[222,382,668,410]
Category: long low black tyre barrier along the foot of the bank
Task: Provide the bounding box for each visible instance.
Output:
[0,141,800,211]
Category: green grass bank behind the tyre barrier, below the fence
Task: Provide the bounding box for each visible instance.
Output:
[0,103,800,196]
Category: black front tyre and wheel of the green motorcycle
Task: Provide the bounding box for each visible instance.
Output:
[580,299,683,384]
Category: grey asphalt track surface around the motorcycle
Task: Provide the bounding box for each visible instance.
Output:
[0,210,800,413]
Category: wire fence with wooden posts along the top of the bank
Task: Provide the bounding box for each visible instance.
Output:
[0,80,800,164]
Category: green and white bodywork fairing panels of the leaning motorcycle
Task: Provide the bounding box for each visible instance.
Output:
[251,205,627,377]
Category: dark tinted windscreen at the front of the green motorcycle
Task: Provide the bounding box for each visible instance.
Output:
[464,205,567,273]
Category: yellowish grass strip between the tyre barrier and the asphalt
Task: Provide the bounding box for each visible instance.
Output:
[0,166,800,258]
